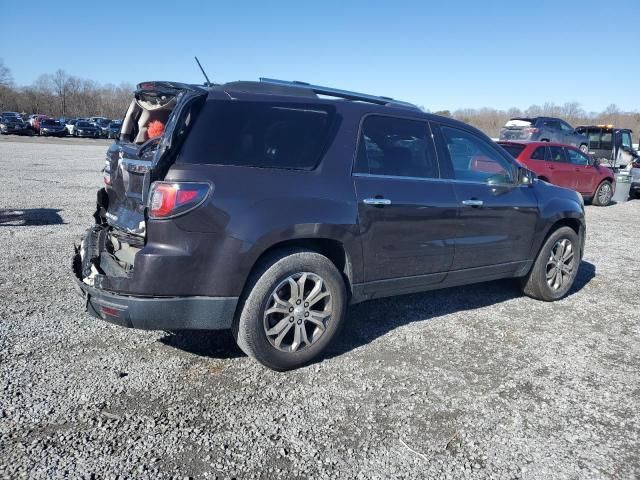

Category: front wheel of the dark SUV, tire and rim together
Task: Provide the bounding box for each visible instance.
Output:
[520,227,581,302]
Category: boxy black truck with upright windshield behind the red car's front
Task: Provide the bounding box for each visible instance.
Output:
[576,125,639,169]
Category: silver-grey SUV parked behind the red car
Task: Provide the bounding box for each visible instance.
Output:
[500,117,589,153]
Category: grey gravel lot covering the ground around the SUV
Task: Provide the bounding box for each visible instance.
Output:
[0,138,640,479]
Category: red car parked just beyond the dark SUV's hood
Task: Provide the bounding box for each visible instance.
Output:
[498,142,615,206]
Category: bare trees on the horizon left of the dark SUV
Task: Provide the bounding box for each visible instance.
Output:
[0,60,134,118]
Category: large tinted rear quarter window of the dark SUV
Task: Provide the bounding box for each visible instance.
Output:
[179,102,335,170]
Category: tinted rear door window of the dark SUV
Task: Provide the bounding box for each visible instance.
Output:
[356,116,439,178]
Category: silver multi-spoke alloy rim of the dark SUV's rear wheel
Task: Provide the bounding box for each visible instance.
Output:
[264,272,332,352]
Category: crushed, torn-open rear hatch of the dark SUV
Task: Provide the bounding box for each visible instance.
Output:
[73,82,208,291]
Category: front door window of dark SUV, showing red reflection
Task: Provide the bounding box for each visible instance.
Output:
[442,126,513,183]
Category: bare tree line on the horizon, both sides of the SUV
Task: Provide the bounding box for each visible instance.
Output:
[0,59,640,138]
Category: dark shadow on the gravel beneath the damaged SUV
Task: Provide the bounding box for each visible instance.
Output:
[160,261,596,363]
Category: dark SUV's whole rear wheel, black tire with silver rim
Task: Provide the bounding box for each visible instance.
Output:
[232,250,347,371]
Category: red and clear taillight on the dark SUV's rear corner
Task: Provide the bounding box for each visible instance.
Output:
[149,182,211,218]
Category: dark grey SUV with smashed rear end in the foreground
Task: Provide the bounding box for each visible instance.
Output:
[73,80,585,370]
